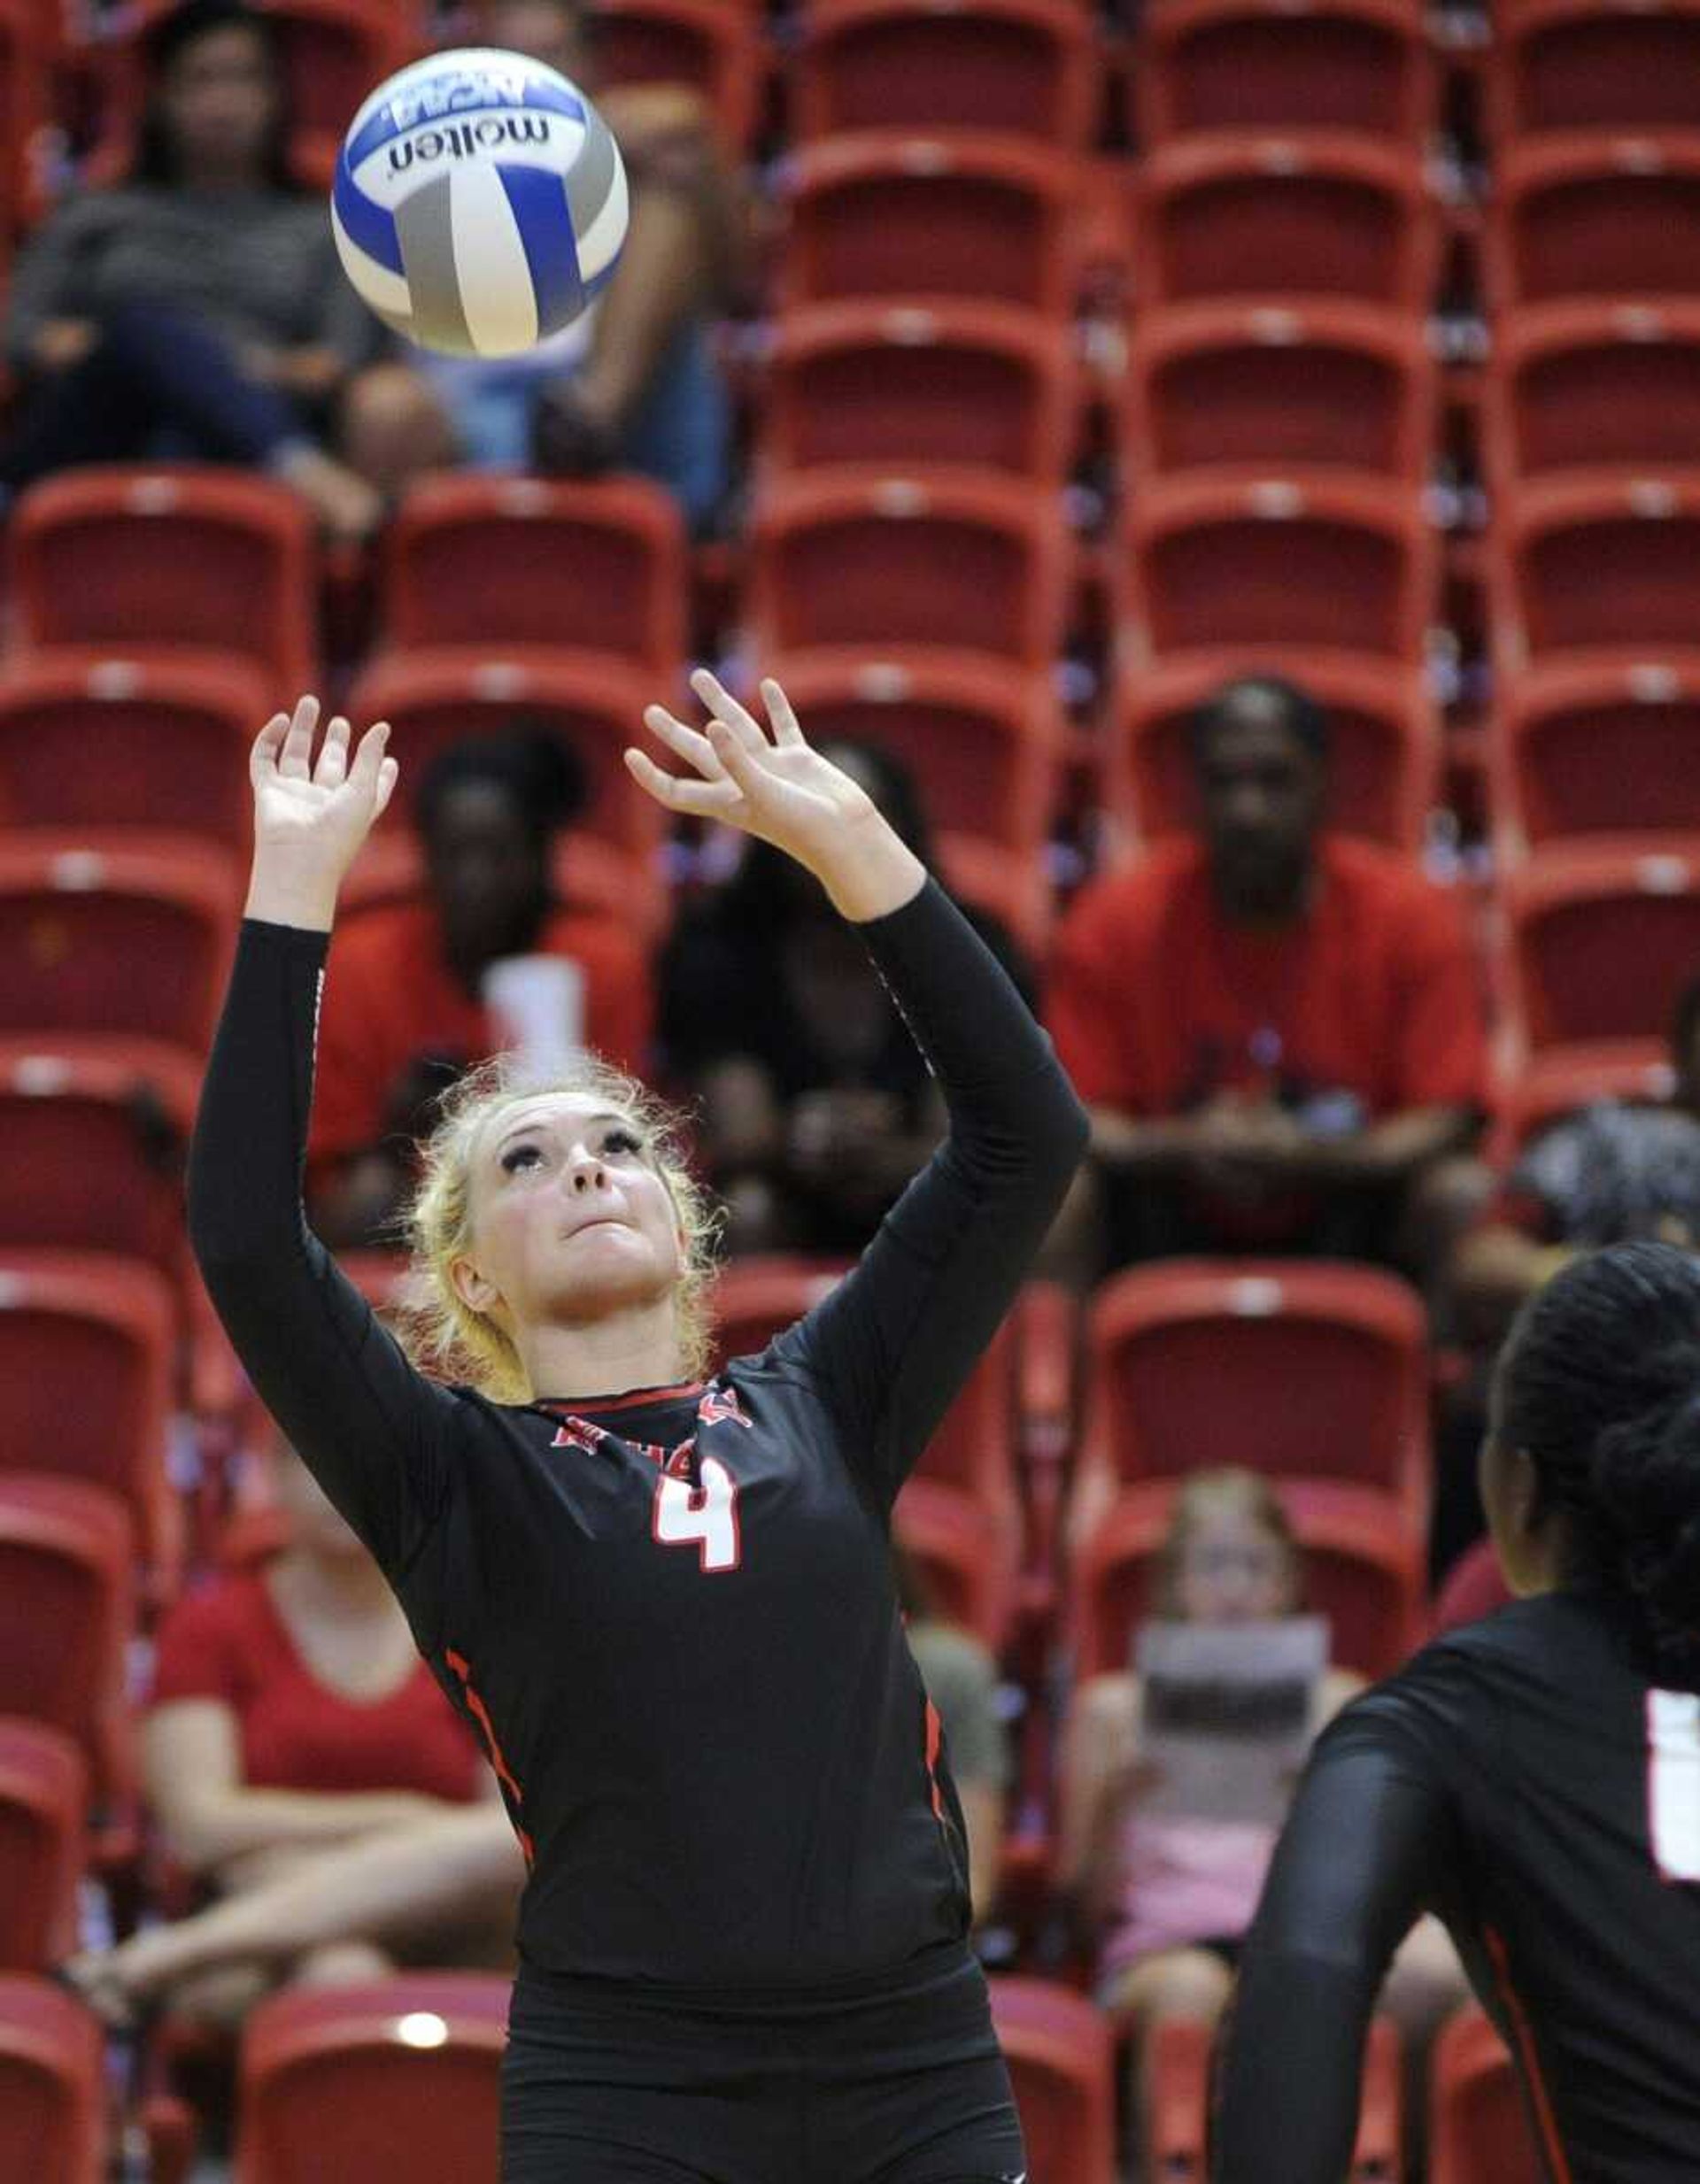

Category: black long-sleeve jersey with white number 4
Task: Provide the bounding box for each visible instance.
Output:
[190,880,1086,1994]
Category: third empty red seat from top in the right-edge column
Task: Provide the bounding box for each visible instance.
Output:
[1484,298,1700,490]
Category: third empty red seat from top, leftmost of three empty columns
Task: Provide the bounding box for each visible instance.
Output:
[761,298,1078,490]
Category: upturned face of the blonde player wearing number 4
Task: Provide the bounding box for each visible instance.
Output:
[463,1094,684,1325]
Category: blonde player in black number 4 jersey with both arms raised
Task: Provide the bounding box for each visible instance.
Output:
[190,675,1086,2184]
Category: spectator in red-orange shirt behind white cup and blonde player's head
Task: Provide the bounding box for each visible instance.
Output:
[308,728,651,1247]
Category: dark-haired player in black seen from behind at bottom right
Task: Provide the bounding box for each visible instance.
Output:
[1213,1243,1700,2184]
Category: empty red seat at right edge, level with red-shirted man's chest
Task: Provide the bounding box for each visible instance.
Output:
[1501,837,1700,1053]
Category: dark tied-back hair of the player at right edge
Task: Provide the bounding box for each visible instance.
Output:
[1496,1243,1700,1690]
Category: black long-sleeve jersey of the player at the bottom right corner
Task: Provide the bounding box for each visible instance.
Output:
[1213,1592,1700,2184]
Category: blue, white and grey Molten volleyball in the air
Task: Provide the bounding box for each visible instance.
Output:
[330,48,627,356]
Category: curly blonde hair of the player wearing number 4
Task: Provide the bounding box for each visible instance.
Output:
[400,1055,723,1402]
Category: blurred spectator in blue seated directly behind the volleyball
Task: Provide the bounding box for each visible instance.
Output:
[410,0,749,530]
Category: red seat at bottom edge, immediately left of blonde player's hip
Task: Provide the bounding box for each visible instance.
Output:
[236,1972,509,2184]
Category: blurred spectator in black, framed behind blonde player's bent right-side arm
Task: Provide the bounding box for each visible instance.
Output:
[660,743,1033,1254]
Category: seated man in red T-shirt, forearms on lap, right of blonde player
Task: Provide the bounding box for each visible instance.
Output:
[1045,675,1486,1282]
